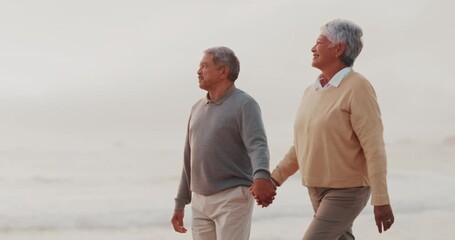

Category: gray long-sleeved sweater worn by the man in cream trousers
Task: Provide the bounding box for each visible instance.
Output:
[175,85,270,209]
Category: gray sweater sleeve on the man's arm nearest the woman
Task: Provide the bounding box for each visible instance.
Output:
[240,101,270,179]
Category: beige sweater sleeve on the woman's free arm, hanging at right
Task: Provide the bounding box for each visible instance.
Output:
[351,79,390,205]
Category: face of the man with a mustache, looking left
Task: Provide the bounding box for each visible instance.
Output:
[197,53,223,91]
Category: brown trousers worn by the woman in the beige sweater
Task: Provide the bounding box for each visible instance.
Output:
[303,187,370,240]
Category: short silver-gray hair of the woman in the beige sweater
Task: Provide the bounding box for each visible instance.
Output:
[321,19,363,67]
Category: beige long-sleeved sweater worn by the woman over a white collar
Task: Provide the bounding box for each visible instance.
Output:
[272,71,390,205]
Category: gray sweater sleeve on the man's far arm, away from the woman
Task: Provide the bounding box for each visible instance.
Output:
[174,118,191,209]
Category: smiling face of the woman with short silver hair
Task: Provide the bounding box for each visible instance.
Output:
[311,35,337,70]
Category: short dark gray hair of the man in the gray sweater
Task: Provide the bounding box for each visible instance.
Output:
[204,47,240,82]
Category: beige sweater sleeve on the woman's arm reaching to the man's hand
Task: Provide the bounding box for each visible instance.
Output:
[272,145,299,186]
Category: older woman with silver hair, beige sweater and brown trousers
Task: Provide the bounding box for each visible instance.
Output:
[272,19,394,240]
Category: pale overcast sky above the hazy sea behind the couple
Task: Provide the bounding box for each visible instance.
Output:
[0,0,455,153]
